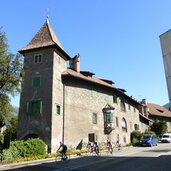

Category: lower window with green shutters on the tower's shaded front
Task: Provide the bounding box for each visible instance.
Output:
[27,100,42,115]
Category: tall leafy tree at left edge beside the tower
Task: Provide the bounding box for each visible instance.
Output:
[0,28,23,121]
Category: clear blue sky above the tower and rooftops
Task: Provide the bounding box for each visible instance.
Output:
[0,0,171,106]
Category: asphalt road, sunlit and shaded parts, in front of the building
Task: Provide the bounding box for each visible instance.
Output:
[0,143,171,171]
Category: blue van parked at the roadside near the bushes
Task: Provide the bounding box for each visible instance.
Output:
[140,134,158,147]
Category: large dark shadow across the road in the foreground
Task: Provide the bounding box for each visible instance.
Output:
[1,154,171,171]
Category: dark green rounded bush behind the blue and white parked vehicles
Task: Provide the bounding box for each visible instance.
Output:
[151,120,167,136]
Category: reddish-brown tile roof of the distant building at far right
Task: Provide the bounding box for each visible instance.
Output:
[147,103,171,117]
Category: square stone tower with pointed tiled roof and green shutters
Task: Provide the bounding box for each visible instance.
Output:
[18,20,70,152]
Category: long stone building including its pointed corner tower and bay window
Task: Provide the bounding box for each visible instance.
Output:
[17,21,150,152]
